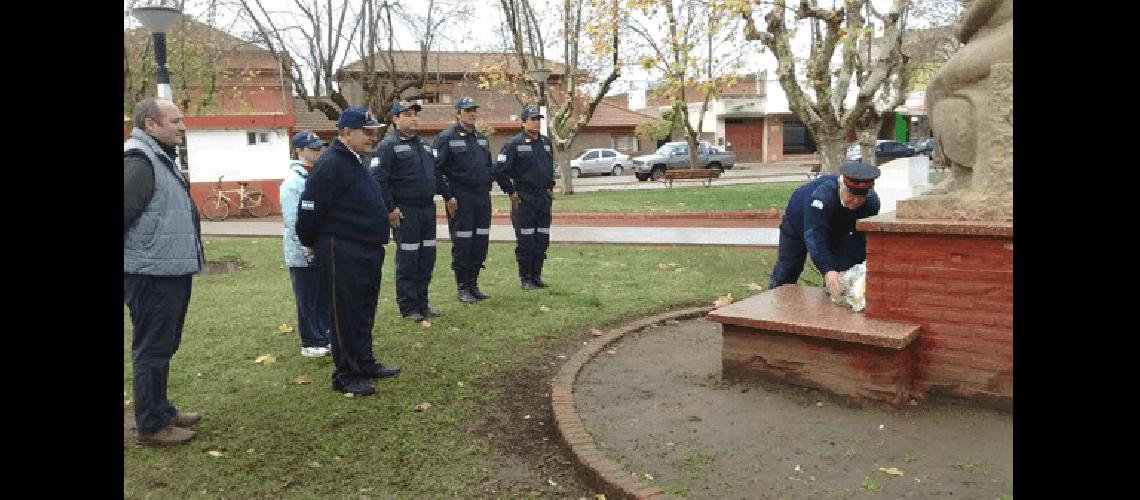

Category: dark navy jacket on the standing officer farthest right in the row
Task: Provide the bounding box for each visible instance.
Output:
[494,132,554,195]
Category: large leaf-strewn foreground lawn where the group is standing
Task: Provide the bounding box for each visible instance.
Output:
[123,238,819,498]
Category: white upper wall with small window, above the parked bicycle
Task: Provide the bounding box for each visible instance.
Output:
[186,129,290,182]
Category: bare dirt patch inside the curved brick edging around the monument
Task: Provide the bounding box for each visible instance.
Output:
[575,319,1013,499]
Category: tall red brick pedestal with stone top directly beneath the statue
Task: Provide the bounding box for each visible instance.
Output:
[857,213,1013,407]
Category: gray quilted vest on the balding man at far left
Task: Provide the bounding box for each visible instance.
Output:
[123,129,205,276]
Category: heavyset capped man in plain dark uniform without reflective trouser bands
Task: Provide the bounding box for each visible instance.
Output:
[296,107,400,395]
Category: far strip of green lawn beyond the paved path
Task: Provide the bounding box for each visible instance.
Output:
[476,182,804,213]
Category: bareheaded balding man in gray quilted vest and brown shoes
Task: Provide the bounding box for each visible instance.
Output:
[123,98,205,445]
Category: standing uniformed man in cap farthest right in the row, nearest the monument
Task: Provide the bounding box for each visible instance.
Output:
[495,106,554,290]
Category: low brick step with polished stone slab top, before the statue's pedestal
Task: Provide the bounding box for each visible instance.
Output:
[708,285,920,404]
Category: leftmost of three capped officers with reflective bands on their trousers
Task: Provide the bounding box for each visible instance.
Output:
[372,101,439,321]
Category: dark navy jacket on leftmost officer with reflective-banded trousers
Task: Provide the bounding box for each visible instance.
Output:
[371,129,437,212]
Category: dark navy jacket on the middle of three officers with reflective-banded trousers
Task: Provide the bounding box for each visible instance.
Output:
[432,123,491,199]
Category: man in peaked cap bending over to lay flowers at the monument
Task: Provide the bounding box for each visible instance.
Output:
[768,162,879,296]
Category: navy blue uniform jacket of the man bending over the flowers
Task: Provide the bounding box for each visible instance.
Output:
[780,175,879,274]
